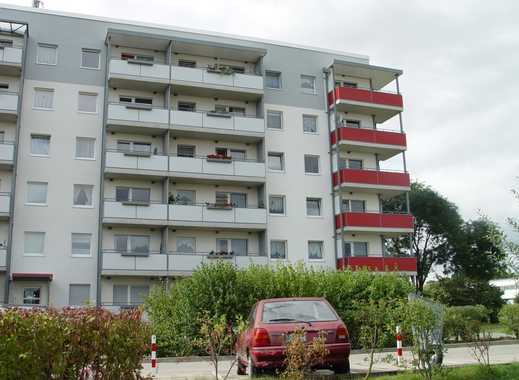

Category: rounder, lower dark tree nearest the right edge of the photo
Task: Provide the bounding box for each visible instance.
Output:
[447,216,507,281]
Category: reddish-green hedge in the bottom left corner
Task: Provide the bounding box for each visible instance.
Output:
[0,308,149,380]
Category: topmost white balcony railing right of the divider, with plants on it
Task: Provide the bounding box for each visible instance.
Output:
[171,66,263,91]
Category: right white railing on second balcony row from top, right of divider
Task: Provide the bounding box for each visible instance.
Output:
[171,110,265,133]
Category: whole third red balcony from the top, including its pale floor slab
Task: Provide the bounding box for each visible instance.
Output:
[333,169,411,197]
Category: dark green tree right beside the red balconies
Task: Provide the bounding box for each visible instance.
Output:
[384,182,463,293]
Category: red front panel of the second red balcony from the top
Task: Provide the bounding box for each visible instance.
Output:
[331,127,407,147]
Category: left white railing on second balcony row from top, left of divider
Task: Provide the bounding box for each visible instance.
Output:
[108,103,168,127]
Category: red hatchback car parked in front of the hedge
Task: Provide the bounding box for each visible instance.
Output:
[236,297,350,377]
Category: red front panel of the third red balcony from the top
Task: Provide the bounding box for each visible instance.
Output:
[333,169,411,187]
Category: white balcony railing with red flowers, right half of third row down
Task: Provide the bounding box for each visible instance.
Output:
[169,156,265,177]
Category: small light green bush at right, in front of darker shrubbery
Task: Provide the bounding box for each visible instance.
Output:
[443,305,490,342]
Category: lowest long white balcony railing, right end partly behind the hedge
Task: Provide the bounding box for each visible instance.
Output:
[102,250,268,276]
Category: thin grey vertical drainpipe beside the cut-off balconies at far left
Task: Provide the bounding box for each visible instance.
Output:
[3,24,29,303]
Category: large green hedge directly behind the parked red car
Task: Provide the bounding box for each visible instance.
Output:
[146,261,412,356]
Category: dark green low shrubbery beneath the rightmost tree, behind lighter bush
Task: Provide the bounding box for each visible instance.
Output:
[425,275,504,322]
